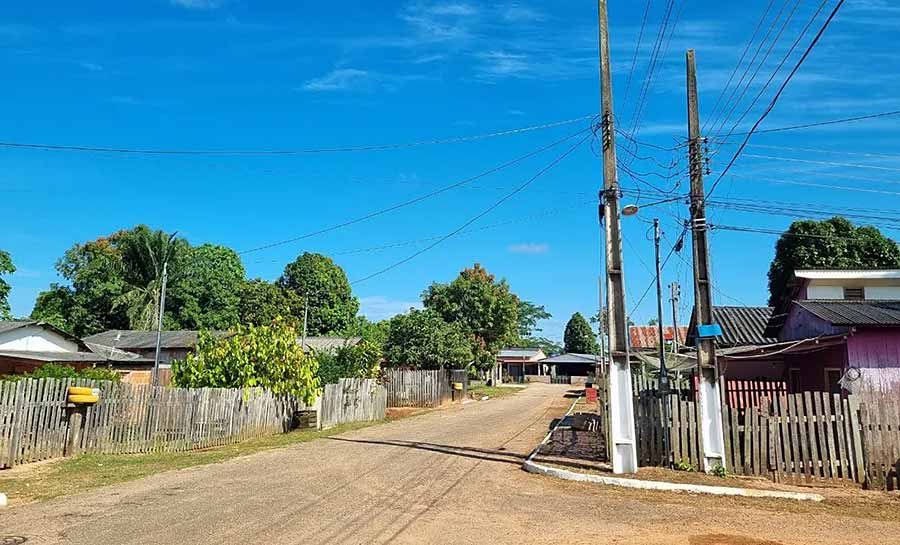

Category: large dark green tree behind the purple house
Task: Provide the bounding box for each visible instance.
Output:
[769,217,900,306]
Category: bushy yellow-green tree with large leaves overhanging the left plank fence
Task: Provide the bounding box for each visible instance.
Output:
[172,321,319,404]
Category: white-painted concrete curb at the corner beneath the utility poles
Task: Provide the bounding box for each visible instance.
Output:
[522,460,825,502]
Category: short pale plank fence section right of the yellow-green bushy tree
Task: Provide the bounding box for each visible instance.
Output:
[320,378,387,428]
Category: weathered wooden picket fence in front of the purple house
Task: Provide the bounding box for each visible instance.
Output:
[635,392,880,483]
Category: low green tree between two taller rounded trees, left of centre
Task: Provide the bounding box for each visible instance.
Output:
[238,278,303,328]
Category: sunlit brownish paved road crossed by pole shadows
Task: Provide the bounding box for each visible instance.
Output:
[0,384,900,545]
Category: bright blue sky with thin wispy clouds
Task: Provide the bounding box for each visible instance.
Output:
[0,0,900,338]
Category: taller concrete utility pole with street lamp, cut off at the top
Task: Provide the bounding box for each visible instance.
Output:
[597,0,637,473]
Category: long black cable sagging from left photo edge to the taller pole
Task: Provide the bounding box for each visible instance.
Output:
[0,114,596,155]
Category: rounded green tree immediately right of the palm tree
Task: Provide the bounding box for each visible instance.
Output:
[166,244,245,329]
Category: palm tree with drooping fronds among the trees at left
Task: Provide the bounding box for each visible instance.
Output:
[114,225,185,330]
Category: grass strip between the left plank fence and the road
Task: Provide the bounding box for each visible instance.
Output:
[0,420,385,505]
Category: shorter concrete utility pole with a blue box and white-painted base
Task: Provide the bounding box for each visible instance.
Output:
[686,49,725,472]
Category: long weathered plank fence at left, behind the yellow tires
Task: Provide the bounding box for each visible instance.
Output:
[0,379,305,468]
